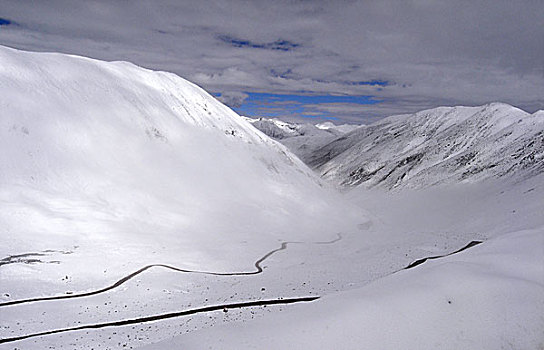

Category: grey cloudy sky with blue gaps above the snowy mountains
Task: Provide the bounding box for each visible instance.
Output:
[0,0,544,123]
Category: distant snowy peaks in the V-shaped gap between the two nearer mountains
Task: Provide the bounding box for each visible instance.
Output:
[245,117,361,162]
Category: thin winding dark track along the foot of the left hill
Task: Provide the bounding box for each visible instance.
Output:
[0,233,342,307]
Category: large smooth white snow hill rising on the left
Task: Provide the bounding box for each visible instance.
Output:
[0,46,356,283]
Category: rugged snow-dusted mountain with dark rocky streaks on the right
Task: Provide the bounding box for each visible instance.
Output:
[308,103,544,189]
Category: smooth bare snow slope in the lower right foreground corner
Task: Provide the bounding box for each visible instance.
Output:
[163,230,544,350]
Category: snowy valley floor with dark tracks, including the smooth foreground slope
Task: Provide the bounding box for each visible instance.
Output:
[0,176,544,350]
